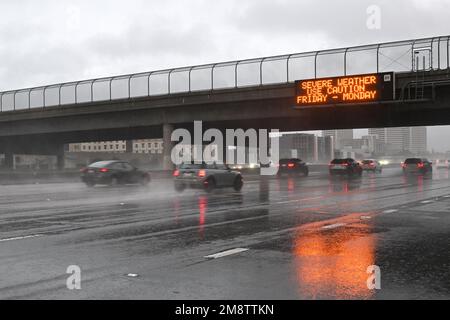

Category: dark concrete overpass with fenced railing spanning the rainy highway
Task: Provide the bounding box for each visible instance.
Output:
[0,36,450,169]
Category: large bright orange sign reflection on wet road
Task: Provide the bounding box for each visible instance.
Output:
[294,219,376,299]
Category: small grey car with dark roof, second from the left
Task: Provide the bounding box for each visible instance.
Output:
[173,163,244,192]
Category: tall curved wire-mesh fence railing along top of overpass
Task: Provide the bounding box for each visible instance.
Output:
[0,36,450,112]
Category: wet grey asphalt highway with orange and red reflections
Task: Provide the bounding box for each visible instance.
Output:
[0,169,450,299]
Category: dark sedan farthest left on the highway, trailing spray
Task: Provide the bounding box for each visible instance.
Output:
[80,160,151,187]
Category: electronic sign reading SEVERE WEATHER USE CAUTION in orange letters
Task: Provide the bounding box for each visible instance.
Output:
[295,72,395,106]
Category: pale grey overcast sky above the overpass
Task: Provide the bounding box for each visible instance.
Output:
[0,0,450,150]
